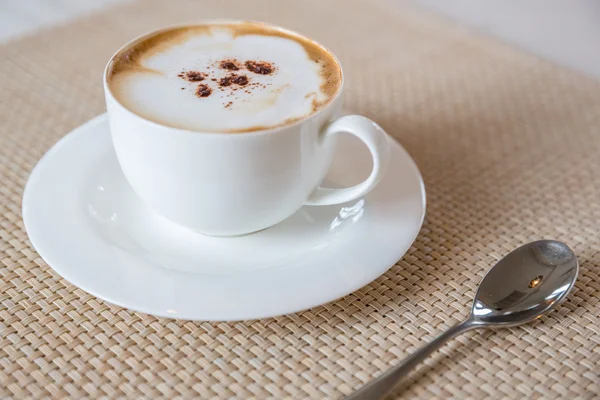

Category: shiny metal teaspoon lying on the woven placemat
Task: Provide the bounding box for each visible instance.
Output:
[346,240,579,400]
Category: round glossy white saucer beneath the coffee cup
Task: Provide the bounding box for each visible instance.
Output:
[23,115,425,320]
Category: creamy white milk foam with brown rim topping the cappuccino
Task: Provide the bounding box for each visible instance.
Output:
[109,24,341,132]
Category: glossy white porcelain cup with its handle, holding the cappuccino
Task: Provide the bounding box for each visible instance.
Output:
[104,23,390,236]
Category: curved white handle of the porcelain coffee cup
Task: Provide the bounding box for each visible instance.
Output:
[305,115,390,206]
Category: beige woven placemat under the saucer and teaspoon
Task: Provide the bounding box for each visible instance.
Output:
[0,0,600,399]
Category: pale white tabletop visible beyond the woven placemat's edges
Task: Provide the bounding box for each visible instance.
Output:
[0,0,600,79]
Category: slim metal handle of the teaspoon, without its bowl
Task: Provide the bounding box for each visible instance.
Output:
[346,318,479,400]
